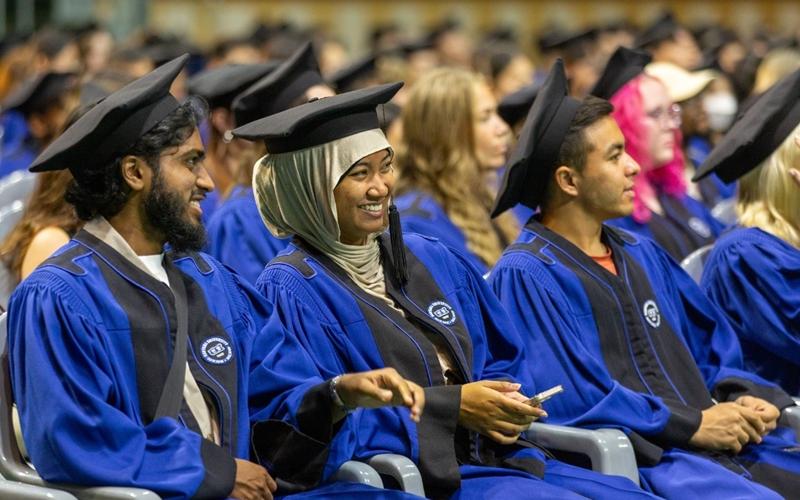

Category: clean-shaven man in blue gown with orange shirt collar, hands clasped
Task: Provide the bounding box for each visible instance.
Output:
[490,59,800,498]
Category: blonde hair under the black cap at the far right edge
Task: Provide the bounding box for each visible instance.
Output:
[736,119,800,248]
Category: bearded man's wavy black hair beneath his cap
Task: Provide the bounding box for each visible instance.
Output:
[66,96,208,221]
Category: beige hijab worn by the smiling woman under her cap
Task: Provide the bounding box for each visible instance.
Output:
[253,129,391,300]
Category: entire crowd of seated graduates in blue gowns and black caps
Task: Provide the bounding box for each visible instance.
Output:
[0,11,800,499]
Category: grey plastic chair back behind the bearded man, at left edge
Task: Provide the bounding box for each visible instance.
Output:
[0,313,44,486]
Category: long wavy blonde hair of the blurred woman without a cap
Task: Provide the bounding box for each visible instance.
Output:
[397,68,519,266]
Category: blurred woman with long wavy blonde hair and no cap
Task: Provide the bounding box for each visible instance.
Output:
[395,68,520,273]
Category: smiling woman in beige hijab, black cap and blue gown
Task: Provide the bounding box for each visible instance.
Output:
[234,84,646,498]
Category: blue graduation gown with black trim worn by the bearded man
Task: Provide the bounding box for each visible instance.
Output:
[8,231,270,498]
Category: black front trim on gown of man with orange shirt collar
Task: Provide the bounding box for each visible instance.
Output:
[516,220,713,454]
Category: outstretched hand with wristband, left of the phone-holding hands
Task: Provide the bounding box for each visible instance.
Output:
[336,368,425,422]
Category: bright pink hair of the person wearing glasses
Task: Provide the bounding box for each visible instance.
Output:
[610,74,686,223]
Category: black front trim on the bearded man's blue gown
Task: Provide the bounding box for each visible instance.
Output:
[48,230,238,490]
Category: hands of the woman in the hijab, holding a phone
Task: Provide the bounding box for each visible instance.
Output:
[458,380,547,444]
